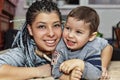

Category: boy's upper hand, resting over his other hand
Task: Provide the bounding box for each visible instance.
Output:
[59,59,84,74]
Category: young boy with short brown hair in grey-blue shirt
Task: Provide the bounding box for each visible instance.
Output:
[52,6,110,80]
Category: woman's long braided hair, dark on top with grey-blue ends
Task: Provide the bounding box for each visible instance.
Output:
[12,0,62,66]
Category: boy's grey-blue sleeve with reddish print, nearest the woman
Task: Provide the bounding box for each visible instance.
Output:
[52,52,64,79]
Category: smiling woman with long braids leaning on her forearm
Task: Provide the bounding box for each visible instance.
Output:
[0,0,62,80]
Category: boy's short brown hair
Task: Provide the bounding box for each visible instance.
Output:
[67,6,100,34]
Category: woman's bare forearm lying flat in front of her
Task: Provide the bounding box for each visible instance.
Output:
[0,64,51,80]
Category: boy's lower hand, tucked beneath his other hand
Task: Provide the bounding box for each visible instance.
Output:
[70,67,82,80]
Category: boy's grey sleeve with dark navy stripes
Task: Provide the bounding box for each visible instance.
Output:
[82,48,101,80]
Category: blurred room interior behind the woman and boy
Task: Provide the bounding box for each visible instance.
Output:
[0,0,120,60]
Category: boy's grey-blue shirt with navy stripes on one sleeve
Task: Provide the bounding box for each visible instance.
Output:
[52,37,108,80]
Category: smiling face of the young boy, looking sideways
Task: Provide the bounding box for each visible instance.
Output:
[63,17,91,50]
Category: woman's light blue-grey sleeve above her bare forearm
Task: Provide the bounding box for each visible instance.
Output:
[0,48,25,66]
